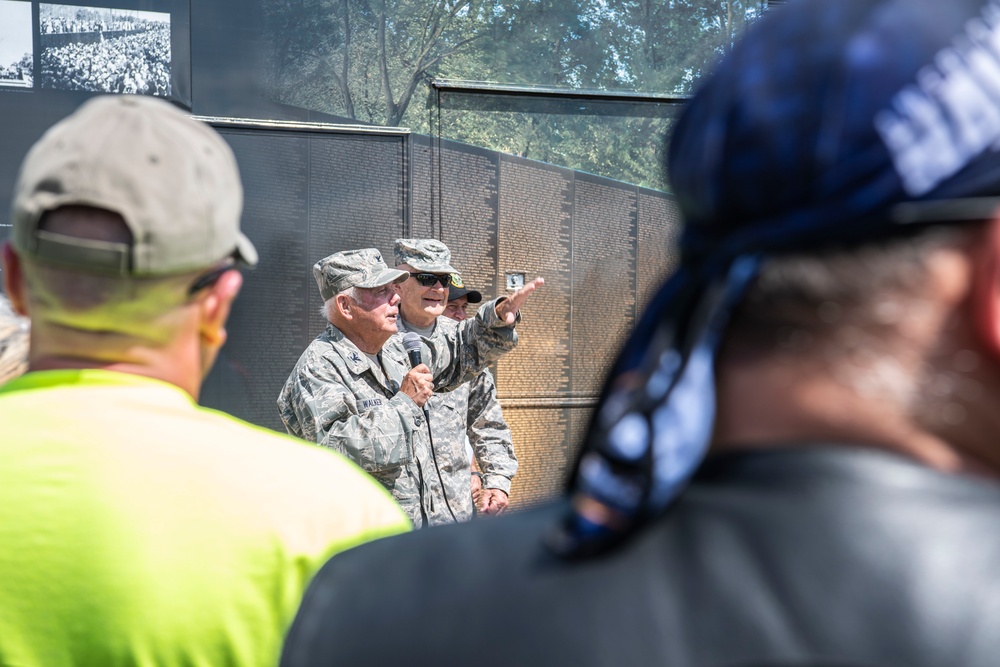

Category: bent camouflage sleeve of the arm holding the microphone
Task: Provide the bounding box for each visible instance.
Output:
[288,363,425,473]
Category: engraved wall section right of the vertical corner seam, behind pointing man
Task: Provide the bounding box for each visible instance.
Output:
[412,137,679,507]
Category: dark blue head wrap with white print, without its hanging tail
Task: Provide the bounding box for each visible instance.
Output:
[668,0,1000,256]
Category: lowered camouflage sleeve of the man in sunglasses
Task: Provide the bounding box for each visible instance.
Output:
[467,370,517,495]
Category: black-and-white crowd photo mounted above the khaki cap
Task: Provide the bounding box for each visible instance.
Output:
[38,4,171,97]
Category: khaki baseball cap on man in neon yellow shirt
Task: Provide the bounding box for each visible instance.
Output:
[11,95,257,276]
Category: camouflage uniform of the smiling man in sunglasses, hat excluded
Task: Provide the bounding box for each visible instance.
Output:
[397,317,517,521]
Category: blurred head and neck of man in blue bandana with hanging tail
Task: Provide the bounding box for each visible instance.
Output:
[553,0,1000,555]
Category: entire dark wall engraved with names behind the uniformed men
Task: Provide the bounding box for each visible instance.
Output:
[188,122,676,507]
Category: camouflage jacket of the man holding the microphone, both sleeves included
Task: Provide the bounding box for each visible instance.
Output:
[278,301,517,527]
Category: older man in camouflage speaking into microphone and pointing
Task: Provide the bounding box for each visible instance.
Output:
[278,248,544,527]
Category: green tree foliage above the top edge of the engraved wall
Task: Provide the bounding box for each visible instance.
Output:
[262,0,766,188]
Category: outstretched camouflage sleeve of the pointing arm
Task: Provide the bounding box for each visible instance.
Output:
[425,297,517,391]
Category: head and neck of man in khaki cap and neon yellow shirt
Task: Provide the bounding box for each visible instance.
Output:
[3,96,257,393]
